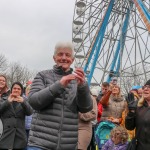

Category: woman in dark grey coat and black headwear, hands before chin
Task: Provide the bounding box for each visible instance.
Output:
[0,82,32,150]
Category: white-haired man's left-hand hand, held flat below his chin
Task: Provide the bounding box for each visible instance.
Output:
[60,74,76,87]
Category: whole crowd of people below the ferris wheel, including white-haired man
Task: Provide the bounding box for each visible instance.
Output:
[0,42,150,150]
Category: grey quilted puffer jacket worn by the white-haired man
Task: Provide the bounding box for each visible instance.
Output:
[28,66,92,150]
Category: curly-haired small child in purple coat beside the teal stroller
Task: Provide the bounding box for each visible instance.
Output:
[102,126,128,150]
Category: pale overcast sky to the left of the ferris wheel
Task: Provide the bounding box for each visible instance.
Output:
[0,0,75,70]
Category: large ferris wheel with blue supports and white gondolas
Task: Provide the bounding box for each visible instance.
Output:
[72,0,150,90]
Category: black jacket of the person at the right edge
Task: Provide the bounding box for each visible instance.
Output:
[125,101,150,150]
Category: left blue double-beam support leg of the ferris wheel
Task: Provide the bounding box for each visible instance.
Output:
[84,0,115,85]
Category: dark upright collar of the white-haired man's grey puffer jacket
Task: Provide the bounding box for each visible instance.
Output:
[53,65,73,75]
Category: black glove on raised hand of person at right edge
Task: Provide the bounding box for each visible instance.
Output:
[126,93,137,111]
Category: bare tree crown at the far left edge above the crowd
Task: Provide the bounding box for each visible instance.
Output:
[0,54,8,73]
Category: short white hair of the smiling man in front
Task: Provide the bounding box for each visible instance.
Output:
[54,42,74,57]
